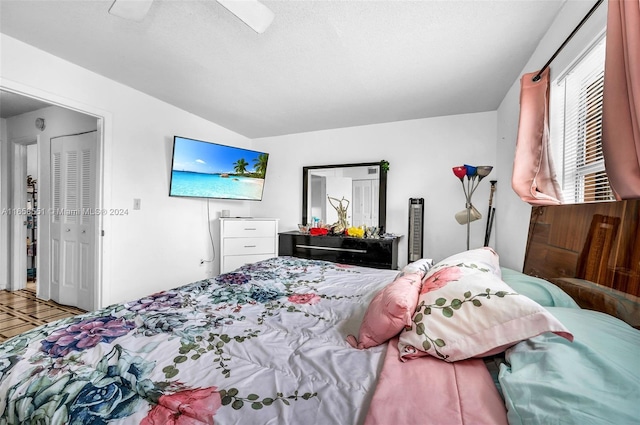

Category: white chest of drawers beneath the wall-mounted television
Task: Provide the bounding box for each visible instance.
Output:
[220,218,278,273]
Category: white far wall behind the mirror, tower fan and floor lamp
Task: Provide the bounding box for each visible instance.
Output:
[251,112,496,267]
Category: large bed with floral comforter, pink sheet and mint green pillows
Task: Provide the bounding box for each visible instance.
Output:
[0,249,640,425]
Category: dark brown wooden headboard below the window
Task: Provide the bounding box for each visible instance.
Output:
[523,200,640,327]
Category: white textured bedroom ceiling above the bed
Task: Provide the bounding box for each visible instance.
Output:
[0,0,567,138]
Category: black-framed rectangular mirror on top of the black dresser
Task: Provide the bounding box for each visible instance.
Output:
[301,162,387,234]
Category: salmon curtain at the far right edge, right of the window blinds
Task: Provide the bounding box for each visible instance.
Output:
[602,0,640,200]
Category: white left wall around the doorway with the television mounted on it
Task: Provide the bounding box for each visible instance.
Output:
[0,34,251,305]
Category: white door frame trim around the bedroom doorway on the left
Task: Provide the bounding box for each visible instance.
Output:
[0,79,113,309]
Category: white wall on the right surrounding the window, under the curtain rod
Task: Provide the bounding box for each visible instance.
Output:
[494,1,607,270]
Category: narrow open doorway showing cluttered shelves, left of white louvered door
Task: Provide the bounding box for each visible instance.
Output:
[25,144,38,290]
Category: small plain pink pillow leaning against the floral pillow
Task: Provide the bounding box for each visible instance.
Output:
[347,271,423,349]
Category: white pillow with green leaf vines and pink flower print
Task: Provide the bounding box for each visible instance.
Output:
[398,248,573,362]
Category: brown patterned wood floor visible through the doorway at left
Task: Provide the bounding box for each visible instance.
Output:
[0,282,84,342]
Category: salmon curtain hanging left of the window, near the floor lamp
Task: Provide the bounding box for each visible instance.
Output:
[511,68,562,205]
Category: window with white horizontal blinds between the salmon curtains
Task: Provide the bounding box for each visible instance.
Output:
[550,37,615,204]
